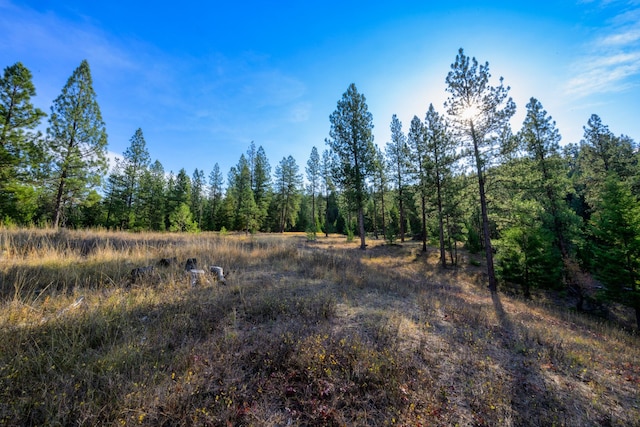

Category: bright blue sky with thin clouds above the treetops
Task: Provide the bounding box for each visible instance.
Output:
[0,0,640,184]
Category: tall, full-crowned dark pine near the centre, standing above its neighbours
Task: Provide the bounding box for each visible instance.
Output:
[328,83,375,249]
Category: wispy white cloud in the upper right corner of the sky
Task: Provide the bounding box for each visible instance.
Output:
[565,2,640,97]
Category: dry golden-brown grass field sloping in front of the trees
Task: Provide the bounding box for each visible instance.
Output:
[0,230,640,426]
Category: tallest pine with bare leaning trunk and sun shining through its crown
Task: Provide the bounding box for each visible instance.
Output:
[445,48,516,292]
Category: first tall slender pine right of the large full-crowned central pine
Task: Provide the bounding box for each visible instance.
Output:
[386,114,411,242]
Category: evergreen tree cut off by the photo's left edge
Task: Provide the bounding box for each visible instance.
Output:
[0,62,45,222]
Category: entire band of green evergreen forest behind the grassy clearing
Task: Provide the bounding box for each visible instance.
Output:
[0,49,640,326]
